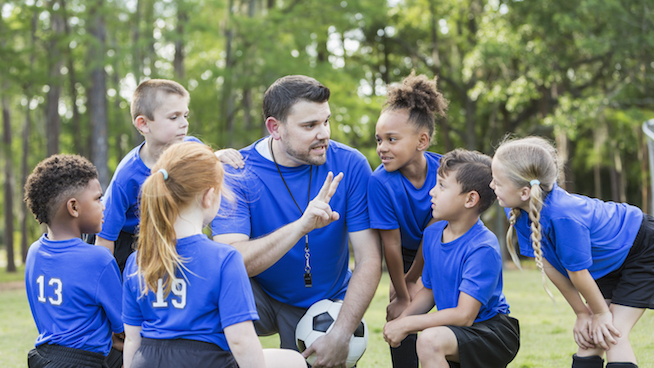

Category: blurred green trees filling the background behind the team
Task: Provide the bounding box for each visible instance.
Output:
[0,0,654,270]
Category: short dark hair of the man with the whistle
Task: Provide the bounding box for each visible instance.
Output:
[263,75,330,122]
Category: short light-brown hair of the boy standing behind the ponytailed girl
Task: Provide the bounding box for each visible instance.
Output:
[130,79,190,122]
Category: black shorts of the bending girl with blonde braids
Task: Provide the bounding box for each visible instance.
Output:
[596,214,654,309]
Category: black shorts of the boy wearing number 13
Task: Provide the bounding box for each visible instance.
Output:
[27,344,107,368]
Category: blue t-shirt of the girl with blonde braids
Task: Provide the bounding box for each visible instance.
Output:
[505,184,643,279]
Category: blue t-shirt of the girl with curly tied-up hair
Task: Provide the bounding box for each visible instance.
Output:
[368,152,441,250]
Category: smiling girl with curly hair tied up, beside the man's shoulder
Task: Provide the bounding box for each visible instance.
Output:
[368,72,448,368]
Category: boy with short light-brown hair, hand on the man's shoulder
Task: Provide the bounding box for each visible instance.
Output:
[96,79,242,272]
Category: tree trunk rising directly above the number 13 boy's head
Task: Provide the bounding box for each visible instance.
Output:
[45,1,64,156]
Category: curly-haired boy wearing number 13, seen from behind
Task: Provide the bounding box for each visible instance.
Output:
[25,155,123,368]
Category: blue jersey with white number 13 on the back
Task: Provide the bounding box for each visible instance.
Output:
[25,234,123,355]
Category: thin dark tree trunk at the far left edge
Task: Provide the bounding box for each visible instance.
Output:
[2,90,16,272]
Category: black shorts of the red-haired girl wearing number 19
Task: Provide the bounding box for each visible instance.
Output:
[132,338,238,368]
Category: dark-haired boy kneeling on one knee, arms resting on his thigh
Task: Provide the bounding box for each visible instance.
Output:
[384,149,520,368]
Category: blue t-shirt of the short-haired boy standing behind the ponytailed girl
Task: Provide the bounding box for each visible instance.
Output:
[98,136,202,241]
